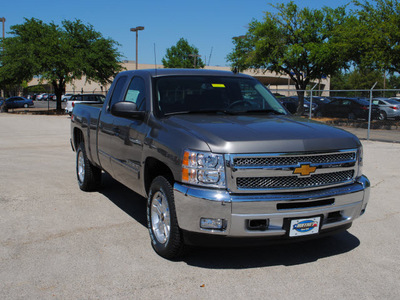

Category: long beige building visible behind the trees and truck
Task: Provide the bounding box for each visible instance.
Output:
[28,61,330,96]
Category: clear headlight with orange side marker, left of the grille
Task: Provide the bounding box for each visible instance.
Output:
[182,150,225,188]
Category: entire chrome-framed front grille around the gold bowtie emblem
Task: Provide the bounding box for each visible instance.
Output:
[226,149,358,193]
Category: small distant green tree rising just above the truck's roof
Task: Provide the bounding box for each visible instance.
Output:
[161,38,204,69]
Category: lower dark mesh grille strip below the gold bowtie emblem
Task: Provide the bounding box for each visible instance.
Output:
[236,170,354,189]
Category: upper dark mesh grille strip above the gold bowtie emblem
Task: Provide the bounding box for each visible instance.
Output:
[233,152,356,167]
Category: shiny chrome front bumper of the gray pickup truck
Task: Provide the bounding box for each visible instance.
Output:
[174,176,370,237]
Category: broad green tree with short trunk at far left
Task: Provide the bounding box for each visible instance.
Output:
[0,18,122,110]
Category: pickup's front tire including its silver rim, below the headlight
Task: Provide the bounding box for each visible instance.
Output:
[147,176,184,259]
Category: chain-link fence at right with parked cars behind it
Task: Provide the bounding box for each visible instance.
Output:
[271,85,400,143]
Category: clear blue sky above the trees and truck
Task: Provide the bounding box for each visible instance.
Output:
[0,0,350,66]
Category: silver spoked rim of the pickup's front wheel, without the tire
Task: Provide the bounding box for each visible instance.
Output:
[151,190,171,244]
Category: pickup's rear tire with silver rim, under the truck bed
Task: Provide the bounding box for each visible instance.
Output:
[76,142,101,192]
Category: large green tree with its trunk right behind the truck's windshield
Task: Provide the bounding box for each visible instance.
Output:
[227,2,348,114]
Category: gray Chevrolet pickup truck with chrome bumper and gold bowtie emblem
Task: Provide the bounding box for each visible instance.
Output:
[71,69,370,259]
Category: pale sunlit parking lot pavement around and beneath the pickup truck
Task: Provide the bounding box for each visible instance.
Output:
[0,114,400,299]
